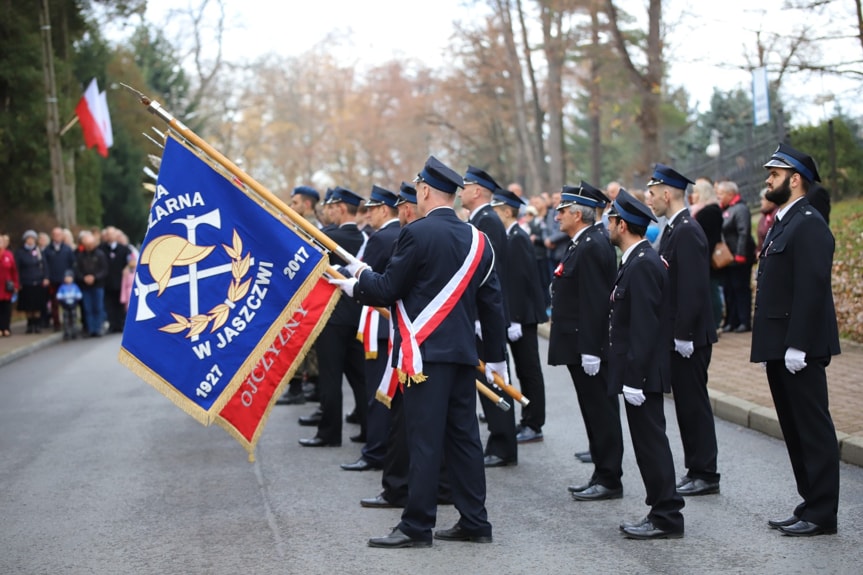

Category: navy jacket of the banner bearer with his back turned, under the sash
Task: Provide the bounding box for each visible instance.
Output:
[354,208,506,365]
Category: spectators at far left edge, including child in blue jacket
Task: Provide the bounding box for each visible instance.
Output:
[0,226,138,339]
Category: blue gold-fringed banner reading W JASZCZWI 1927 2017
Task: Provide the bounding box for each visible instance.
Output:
[120,133,328,425]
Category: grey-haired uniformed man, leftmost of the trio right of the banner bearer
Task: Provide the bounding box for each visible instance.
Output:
[548,182,623,501]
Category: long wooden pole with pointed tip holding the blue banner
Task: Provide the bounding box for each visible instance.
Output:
[121,84,359,262]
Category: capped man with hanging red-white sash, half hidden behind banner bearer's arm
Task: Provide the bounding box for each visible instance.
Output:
[341,186,400,471]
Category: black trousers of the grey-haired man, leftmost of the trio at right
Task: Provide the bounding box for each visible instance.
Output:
[568,361,623,489]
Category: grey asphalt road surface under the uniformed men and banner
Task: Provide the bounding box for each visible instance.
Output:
[0,336,863,575]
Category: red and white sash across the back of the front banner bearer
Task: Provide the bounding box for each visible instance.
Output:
[396,226,485,385]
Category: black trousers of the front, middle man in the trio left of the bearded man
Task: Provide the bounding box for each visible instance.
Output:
[626,392,685,532]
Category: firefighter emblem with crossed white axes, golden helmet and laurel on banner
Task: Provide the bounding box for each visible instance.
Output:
[135,210,253,341]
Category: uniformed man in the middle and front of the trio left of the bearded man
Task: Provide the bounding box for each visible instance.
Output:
[608,189,684,539]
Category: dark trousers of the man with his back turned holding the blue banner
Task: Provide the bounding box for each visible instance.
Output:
[398,362,491,541]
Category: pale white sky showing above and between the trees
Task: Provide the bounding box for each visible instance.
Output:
[132,0,863,124]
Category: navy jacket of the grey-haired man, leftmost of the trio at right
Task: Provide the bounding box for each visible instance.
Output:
[548,226,617,365]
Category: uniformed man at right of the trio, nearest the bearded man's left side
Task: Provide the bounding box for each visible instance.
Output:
[647,164,719,495]
